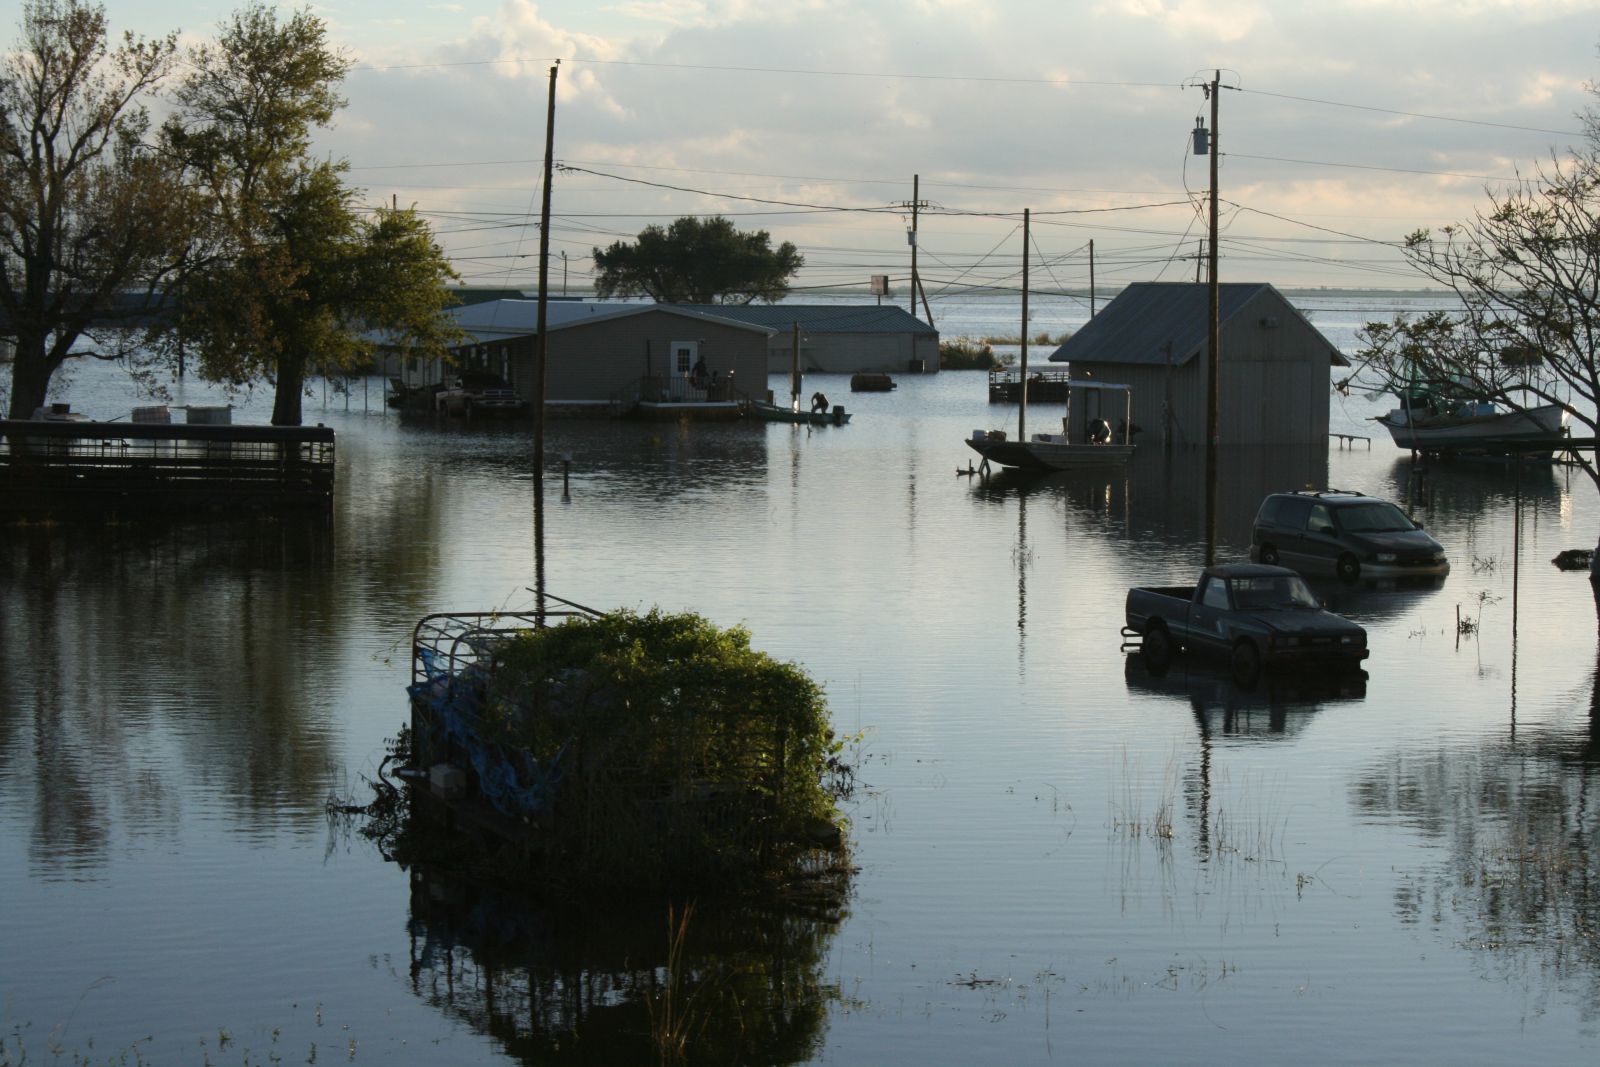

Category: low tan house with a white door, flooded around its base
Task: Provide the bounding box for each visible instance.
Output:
[398,299,771,414]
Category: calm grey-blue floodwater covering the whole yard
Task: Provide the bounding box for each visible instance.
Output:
[0,289,1600,1064]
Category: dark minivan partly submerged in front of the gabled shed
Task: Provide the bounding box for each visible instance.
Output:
[1250,490,1450,581]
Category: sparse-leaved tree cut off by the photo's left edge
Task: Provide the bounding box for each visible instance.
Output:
[0,0,192,419]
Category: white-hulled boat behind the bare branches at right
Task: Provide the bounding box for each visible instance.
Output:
[1373,386,1571,454]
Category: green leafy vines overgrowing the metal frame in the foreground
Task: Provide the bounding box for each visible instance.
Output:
[480,609,842,893]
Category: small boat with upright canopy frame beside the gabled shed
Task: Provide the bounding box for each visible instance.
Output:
[966,379,1134,470]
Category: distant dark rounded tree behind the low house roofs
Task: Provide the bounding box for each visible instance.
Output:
[594,216,805,304]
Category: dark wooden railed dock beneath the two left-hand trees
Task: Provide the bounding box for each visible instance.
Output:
[0,419,333,518]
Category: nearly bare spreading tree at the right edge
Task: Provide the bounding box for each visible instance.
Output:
[1357,78,1600,574]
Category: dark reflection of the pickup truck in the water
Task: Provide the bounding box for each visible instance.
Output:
[1123,653,1366,741]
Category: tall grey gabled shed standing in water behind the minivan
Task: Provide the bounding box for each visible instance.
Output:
[1050,282,1349,448]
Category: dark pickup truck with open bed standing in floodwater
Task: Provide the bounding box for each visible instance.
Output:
[1123,563,1366,678]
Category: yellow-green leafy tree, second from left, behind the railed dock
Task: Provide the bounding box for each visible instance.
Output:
[163,3,458,426]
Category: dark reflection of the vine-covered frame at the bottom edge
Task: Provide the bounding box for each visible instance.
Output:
[408,872,842,1064]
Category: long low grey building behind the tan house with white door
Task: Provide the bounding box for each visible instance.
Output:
[683,304,939,374]
